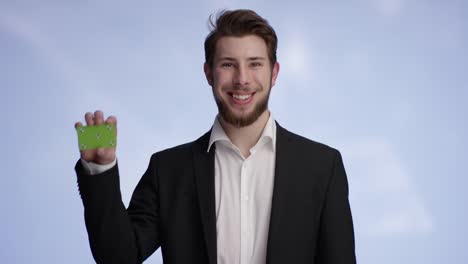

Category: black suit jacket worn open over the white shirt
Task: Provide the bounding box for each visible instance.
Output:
[75,123,356,264]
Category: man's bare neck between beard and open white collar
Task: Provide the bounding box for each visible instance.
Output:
[219,110,270,157]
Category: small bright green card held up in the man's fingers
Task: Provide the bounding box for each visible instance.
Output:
[76,124,117,150]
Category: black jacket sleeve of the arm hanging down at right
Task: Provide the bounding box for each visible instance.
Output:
[317,150,356,264]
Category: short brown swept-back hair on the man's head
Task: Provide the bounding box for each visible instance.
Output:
[205,9,278,67]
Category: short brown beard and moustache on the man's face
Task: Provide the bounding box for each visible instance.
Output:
[212,82,271,128]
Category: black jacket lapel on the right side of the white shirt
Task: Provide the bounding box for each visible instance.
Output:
[266,121,294,263]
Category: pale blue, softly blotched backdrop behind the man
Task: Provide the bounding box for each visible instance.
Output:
[0,0,468,264]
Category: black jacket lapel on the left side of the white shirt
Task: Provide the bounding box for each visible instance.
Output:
[192,130,217,264]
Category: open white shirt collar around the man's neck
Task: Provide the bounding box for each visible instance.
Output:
[206,111,276,152]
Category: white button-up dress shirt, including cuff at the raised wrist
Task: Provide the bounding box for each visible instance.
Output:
[81,112,276,264]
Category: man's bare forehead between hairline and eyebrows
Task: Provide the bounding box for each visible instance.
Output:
[214,35,268,59]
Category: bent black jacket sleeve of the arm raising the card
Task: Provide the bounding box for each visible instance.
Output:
[75,155,160,264]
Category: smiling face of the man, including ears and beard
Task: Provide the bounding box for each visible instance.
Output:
[204,35,279,127]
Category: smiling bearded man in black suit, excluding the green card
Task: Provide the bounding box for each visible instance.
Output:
[75,10,356,264]
